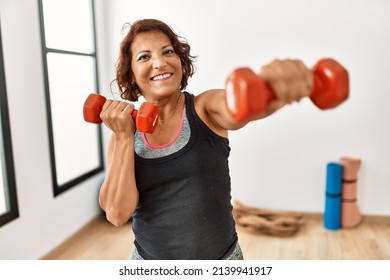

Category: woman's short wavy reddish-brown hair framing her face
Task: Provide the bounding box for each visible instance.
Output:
[111,19,196,101]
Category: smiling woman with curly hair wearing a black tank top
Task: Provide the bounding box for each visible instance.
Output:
[99,19,313,259]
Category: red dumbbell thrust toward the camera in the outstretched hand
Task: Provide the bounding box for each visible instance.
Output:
[226,58,349,122]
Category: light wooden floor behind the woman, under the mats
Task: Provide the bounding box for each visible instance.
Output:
[42,212,390,260]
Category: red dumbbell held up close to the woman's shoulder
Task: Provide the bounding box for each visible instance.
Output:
[83,93,158,133]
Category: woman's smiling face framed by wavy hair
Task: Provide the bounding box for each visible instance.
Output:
[131,31,183,100]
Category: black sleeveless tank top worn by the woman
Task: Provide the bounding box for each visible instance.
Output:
[133,92,237,260]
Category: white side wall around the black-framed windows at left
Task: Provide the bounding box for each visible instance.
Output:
[0,0,102,259]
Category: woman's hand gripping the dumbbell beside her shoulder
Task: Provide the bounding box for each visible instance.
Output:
[100,99,135,139]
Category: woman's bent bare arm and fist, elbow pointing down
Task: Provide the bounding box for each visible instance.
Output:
[99,101,138,226]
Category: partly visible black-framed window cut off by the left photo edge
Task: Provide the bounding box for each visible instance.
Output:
[0,20,19,226]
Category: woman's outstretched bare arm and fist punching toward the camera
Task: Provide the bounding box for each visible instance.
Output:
[195,60,313,136]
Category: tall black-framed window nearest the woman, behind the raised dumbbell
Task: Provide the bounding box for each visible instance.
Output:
[39,0,103,196]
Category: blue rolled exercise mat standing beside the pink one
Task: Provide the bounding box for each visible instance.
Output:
[324,162,343,230]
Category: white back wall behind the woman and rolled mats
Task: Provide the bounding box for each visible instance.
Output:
[107,0,390,215]
